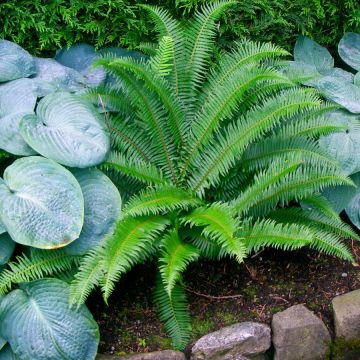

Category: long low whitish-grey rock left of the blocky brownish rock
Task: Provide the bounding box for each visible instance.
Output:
[191,322,271,360]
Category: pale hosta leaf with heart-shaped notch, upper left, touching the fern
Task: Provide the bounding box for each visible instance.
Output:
[20,92,110,168]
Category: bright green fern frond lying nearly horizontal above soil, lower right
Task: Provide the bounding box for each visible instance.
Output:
[240,219,314,252]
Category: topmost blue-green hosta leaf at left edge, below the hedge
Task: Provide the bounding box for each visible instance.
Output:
[0,39,36,82]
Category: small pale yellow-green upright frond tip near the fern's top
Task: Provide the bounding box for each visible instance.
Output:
[150,36,174,76]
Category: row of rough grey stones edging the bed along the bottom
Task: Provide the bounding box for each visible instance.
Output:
[96,289,360,360]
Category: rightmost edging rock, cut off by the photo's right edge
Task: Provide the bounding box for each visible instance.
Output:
[332,290,360,340]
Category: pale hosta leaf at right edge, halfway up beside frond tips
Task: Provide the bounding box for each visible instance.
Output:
[319,110,360,174]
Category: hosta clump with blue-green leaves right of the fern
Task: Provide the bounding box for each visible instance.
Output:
[288,33,360,229]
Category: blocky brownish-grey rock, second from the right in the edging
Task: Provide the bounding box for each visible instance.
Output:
[272,305,330,360]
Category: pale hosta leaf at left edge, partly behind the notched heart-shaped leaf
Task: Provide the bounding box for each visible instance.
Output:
[0,79,38,155]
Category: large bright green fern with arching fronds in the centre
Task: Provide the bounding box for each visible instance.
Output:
[67,1,357,348]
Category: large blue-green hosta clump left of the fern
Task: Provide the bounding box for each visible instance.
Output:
[0,35,131,360]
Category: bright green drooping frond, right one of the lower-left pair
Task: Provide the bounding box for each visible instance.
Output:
[101,216,169,301]
